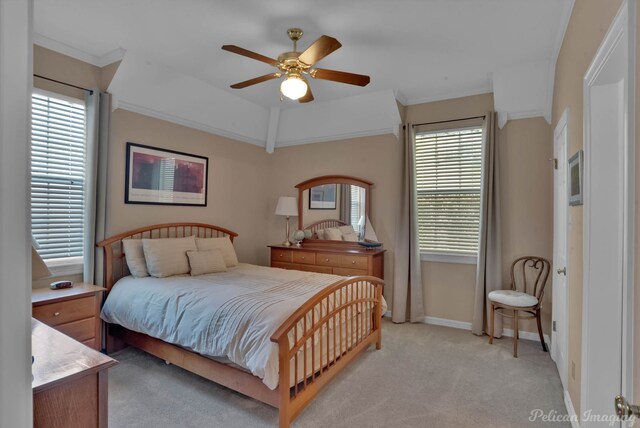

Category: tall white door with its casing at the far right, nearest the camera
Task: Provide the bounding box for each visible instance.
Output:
[580,0,635,428]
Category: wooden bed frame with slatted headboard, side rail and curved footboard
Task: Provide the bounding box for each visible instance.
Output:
[97,223,384,427]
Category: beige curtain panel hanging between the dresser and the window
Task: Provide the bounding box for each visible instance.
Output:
[391,124,424,323]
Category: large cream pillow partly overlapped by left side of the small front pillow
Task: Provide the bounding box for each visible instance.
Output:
[142,236,197,278]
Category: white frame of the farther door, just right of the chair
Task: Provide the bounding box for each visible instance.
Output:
[551,107,571,389]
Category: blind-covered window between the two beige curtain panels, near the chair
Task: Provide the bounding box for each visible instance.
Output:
[415,127,482,263]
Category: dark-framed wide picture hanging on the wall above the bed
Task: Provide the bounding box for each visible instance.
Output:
[124,142,209,207]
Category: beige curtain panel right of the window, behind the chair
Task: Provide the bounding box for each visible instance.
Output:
[471,112,503,337]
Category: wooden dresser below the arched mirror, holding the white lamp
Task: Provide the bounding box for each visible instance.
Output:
[269,244,385,279]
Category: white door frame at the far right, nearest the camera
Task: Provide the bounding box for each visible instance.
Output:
[580,0,636,420]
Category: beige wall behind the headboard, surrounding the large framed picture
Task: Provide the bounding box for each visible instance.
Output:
[106,109,275,264]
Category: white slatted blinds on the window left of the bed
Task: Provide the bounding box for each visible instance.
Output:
[31,94,86,260]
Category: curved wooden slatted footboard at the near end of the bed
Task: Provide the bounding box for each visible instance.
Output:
[271,277,384,428]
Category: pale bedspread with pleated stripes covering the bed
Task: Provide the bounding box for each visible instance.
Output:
[101,263,386,389]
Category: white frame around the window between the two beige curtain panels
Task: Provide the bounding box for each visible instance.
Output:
[411,118,485,265]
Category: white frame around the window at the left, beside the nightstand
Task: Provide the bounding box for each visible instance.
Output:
[29,87,87,277]
